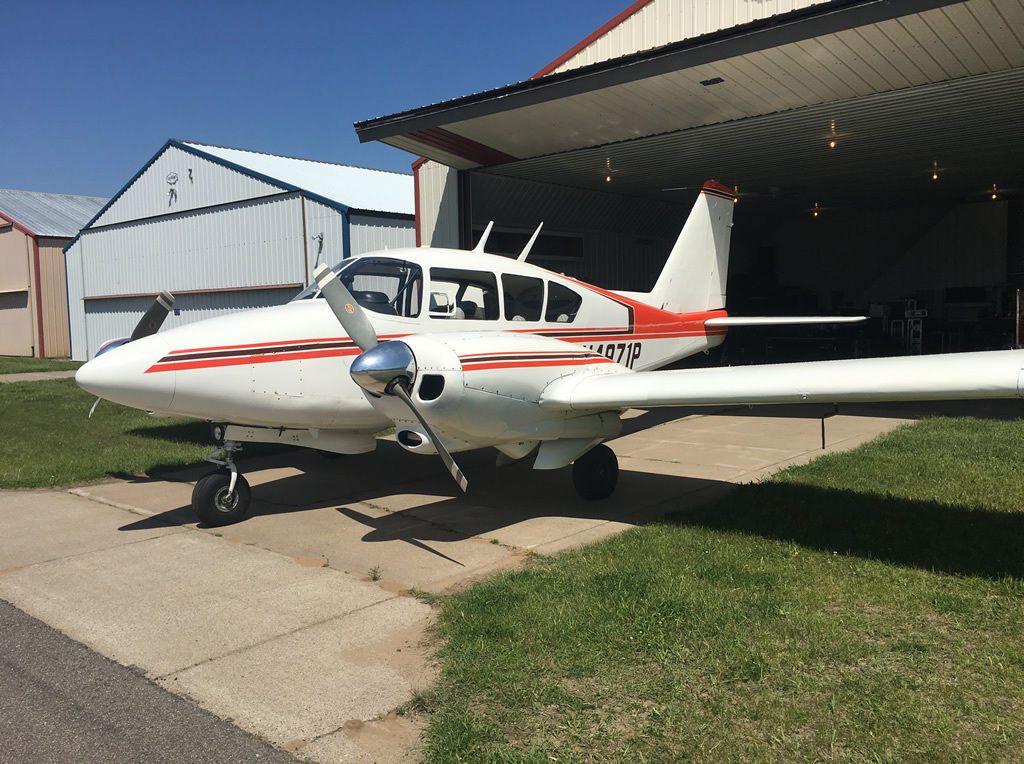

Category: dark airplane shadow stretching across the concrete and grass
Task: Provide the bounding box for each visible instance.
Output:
[121,410,1024,579]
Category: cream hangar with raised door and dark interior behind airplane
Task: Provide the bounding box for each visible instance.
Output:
[356,0,1024,363]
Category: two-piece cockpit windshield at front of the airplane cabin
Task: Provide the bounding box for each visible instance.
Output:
[295,257,423,319]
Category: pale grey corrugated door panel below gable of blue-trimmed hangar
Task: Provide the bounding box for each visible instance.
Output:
[82,195,306,296]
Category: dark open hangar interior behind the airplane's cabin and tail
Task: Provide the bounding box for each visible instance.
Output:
[460,70,1024,363]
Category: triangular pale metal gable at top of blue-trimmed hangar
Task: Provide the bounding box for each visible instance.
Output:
[93,146,282,225]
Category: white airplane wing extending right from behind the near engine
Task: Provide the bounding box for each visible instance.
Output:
[541,350,1024,411]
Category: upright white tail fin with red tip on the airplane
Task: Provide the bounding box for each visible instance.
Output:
[637,180,736,313]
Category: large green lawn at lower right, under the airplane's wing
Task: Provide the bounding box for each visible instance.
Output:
[420,418,1024,762]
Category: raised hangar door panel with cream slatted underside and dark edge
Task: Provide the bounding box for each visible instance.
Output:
[355,0,1024,174]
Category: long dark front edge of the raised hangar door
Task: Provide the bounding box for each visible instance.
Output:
[354,0,963,142]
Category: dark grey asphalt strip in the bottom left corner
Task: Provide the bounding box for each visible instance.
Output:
[0,600,294,763]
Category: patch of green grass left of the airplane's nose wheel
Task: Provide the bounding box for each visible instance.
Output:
[0,379,211,489]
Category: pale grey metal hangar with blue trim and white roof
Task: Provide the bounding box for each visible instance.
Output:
[65,140,415,360]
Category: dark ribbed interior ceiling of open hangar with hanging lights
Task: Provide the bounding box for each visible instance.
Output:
[475,69,1024,207]
